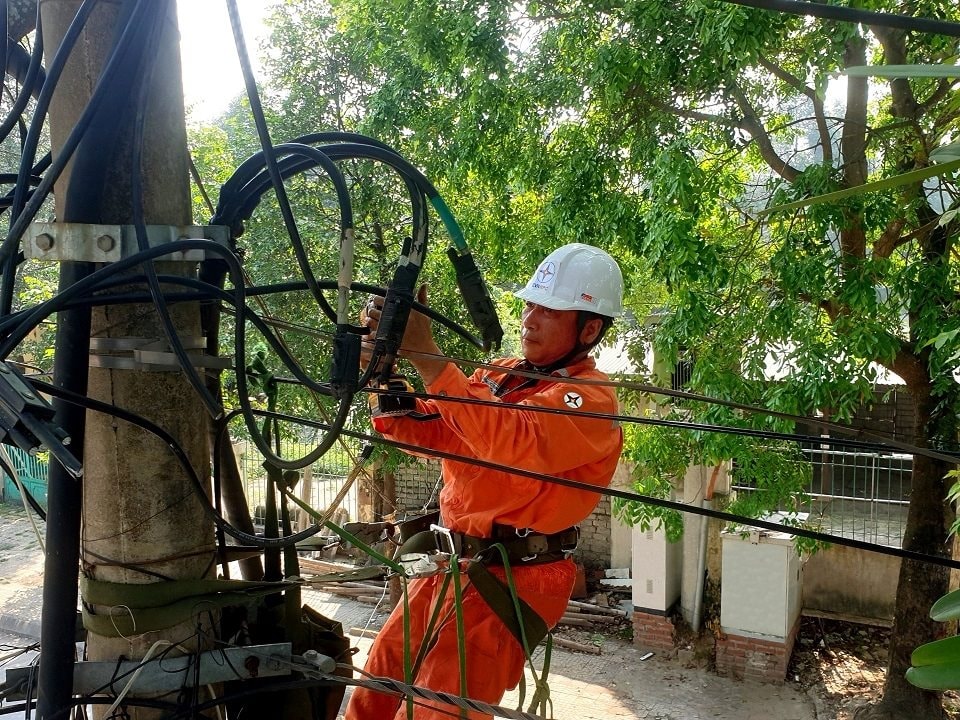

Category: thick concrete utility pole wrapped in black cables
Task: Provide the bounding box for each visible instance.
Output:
[40,0,216,717]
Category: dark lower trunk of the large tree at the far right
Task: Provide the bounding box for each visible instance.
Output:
[856,388,951,720]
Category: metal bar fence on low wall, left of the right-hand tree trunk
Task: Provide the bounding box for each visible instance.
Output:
[733,447,913,547]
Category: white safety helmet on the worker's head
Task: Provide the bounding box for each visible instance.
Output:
[515,243,623,318]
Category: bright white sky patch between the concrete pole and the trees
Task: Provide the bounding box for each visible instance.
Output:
[177,0,274,122]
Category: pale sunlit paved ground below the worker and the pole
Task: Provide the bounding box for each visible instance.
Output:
[0,504,816,720]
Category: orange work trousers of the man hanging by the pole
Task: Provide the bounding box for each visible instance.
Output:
[345,559,576,720]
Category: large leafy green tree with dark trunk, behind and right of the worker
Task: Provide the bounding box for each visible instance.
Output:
[201,0,960,718]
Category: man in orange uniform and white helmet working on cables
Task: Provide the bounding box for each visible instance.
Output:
[346,243,623,720]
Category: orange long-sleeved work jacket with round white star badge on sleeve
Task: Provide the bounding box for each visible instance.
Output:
[374,358,623,537]
